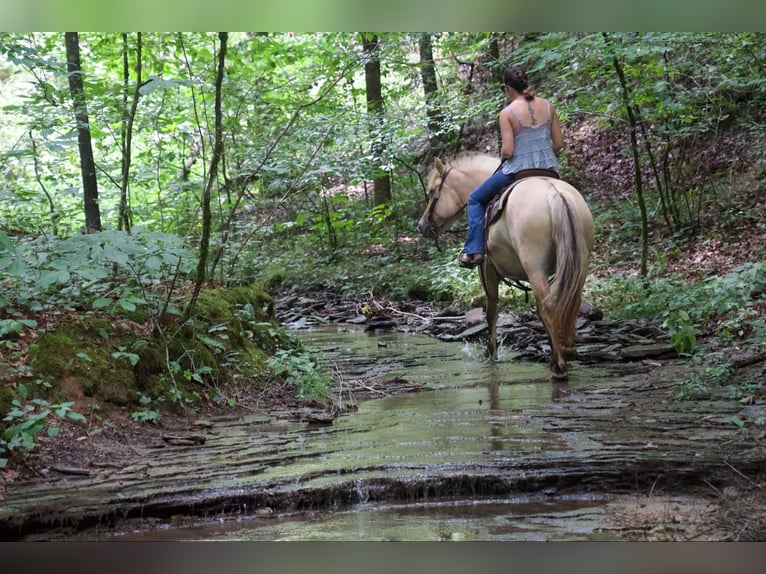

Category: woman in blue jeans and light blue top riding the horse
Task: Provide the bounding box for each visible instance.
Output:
[458,67,564,269]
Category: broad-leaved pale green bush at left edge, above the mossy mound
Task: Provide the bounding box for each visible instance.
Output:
[0,229,194,320]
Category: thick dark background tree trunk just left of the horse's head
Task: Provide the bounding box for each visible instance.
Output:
[362,32,391,205]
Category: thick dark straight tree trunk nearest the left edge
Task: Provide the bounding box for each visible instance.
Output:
[64,32,101,233]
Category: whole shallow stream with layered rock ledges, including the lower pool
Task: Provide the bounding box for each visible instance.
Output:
[0,325,763,540]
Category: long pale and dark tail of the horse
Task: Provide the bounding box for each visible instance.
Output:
[545,190,590,353]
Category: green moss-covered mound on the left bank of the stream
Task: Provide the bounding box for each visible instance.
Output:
[17,286,299,418]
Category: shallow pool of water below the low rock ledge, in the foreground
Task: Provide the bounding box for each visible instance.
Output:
[108,496,618,542]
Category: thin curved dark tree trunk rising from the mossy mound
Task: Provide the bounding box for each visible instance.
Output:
[184,32,228,320]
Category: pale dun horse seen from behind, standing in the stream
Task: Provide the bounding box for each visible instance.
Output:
[418,153,593,381]
